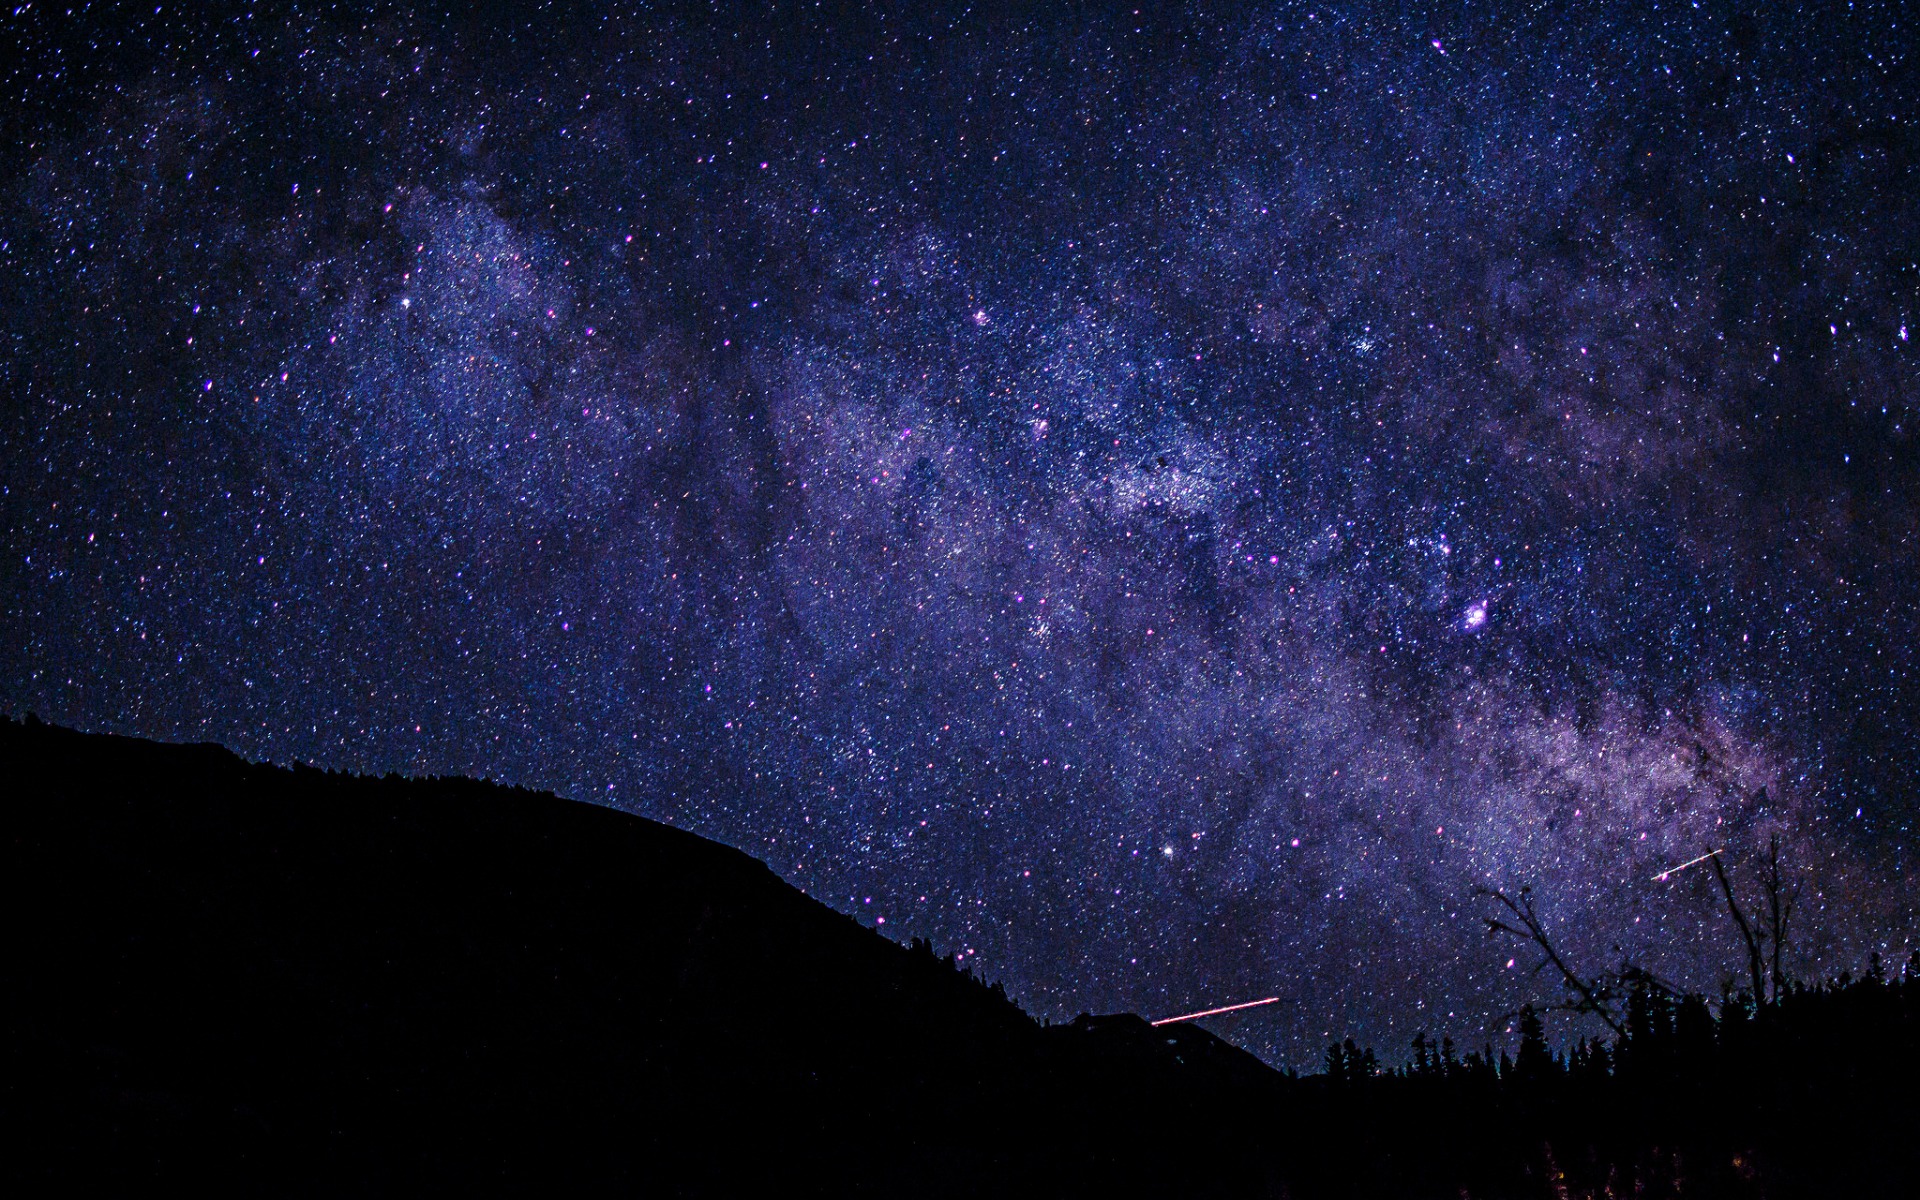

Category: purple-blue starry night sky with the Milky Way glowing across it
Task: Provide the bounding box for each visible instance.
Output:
[0,0,1920,1066]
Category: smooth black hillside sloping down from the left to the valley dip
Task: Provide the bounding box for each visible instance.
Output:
[0,722,1279,1194]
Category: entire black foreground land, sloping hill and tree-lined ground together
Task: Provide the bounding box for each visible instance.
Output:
[0,722,1920,1198]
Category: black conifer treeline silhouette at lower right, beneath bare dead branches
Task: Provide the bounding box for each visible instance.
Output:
[1296,963,1920,1198]
